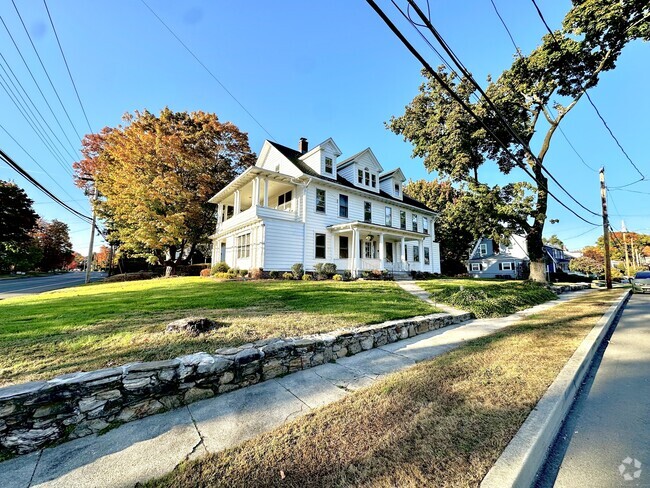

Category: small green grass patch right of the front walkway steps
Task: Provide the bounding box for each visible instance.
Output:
[418,279,557,318]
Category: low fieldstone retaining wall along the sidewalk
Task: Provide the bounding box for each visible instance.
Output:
[0,314,471,454]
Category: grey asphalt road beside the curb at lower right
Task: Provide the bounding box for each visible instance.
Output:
[537,295,650,488]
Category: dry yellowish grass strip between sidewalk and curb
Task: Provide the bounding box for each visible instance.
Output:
[148,290,621,488]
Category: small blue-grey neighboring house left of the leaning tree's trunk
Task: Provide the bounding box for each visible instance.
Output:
[467,235,529,278]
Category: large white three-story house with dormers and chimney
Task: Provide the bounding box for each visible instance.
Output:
[210,138,440,276]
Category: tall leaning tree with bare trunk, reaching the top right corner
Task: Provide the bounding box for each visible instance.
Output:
[388,0,650,281]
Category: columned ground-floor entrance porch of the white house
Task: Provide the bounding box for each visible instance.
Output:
[328,221,431,277]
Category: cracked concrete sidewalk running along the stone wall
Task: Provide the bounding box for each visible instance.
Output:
[0,291,590,488]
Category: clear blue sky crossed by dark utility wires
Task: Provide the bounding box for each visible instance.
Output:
[0,0,650,254]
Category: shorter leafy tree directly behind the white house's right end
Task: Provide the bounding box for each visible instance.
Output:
[404,180,532,275]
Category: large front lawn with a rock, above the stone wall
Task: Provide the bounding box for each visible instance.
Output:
[0,278,435,386]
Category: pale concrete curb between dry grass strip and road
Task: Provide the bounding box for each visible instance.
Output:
[480,290,631,488]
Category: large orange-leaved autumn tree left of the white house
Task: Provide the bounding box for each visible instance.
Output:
[75,108,255,267]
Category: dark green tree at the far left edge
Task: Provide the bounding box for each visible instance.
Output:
[0,180,39,273]
